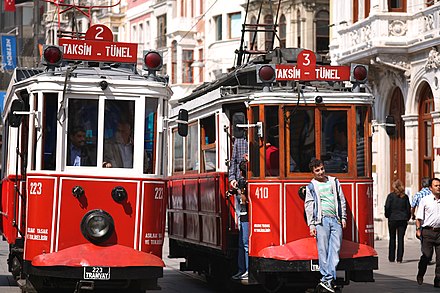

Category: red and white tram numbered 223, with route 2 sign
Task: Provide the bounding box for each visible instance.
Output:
[1,25,172,292]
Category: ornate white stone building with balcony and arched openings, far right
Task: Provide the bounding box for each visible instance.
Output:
[330,0,440,238]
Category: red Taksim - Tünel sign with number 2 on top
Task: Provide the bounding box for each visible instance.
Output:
[59,24,137,63]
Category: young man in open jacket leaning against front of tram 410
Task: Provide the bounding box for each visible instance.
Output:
[304,159,347,292]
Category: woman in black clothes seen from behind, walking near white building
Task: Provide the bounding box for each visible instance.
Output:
[385,179,411,263]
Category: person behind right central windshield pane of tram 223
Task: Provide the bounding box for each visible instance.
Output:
[102,120,134,168]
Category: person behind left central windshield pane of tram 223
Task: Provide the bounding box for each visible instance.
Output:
[67,126,96,166]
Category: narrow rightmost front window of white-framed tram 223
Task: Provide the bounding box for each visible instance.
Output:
[144,98,157,174]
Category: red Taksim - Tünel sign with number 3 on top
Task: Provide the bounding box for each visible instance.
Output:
[275,50,350,81]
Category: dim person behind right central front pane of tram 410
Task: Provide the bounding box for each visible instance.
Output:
[324,123,348,173]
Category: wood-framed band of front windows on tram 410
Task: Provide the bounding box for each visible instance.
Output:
[250,105,371,177]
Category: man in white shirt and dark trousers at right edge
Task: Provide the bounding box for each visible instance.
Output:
[416,178,440,288]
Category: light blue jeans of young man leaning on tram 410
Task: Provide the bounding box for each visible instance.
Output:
[316,216,342,281]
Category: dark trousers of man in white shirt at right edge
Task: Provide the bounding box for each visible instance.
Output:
[417,229,440,282]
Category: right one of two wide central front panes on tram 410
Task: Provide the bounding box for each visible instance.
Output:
[321,110,348,173]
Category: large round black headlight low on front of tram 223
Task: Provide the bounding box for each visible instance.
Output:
[81,209,115,243]
